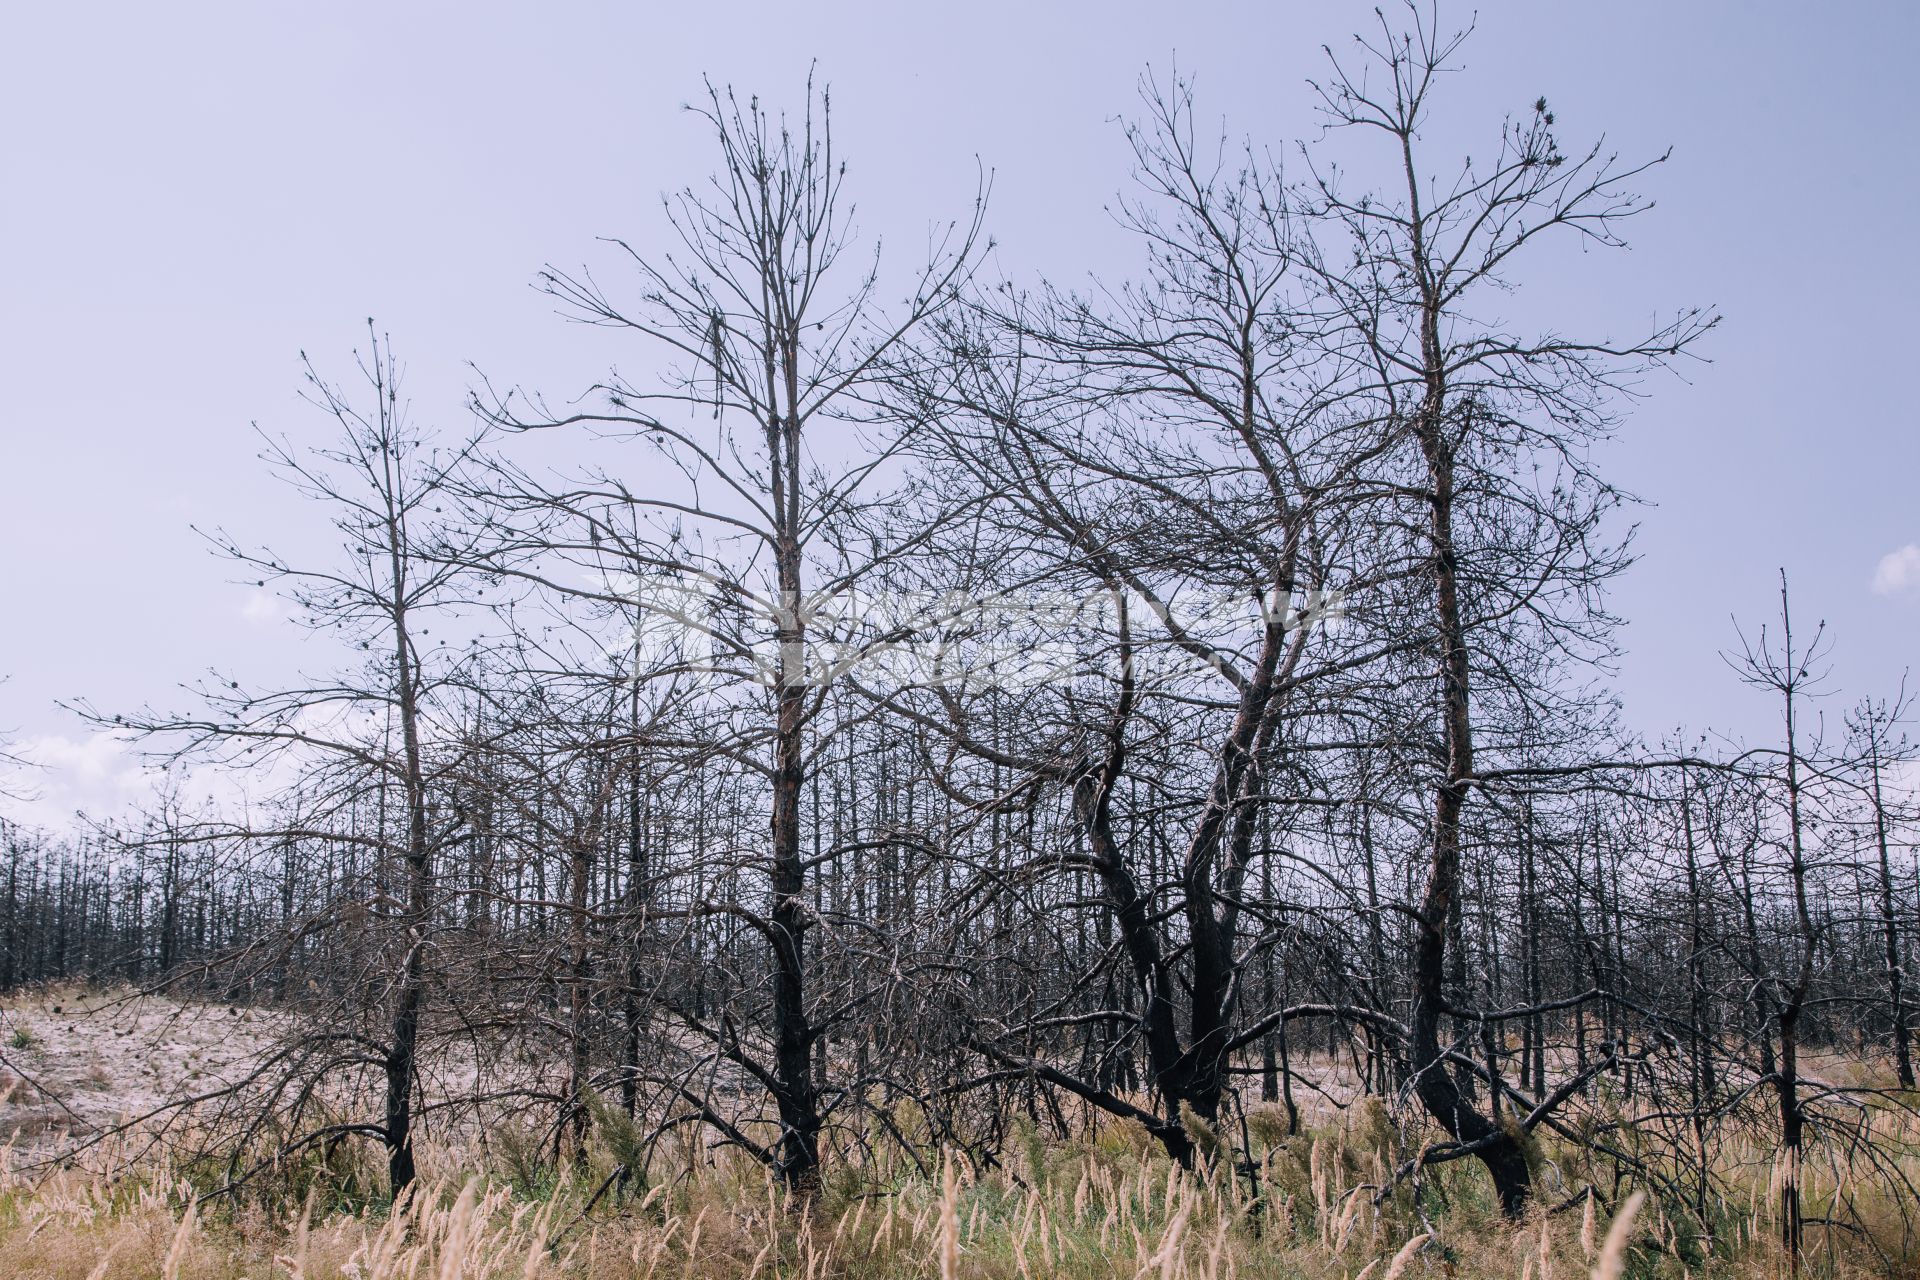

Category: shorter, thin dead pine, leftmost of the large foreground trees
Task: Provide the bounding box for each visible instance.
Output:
[81,322,491,1197]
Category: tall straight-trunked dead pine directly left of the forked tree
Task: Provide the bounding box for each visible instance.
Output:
[460,83,983,1188]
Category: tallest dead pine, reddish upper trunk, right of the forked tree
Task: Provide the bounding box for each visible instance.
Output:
[1296,4,1715,1215]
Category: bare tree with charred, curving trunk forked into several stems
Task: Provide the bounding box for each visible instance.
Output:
[897,72,1384,1161]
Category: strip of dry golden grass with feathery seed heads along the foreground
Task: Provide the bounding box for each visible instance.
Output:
[0,1109,1912,1280]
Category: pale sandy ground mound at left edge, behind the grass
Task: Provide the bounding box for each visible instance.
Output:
[0,986,271,1153]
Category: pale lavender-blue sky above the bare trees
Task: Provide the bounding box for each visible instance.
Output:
[0,0,1920,821]
